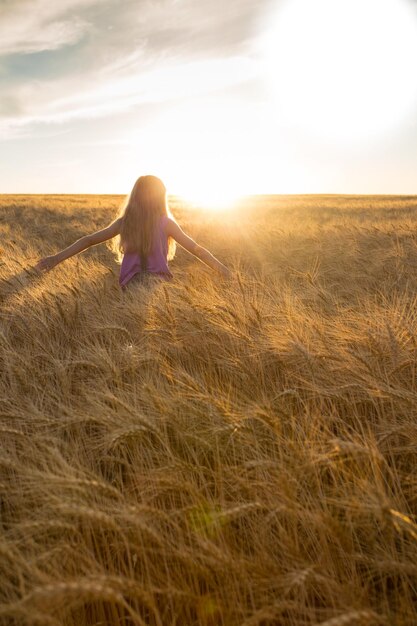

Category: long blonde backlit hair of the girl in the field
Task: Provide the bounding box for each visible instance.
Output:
[115,176,175,269]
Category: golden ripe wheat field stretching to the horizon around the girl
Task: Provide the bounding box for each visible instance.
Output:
[0,196,417,626]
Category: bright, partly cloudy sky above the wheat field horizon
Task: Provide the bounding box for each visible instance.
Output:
[0,0,417,196]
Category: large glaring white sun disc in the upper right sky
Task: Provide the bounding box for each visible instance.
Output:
[263,0,417,142]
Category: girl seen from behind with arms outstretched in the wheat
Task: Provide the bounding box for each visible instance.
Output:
[35,176,230,287]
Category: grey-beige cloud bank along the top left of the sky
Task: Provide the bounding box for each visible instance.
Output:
[0,0,264,58]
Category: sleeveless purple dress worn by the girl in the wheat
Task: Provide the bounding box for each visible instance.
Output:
[119,215,172,287]
